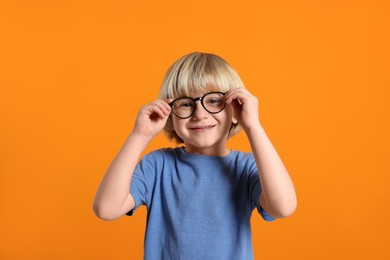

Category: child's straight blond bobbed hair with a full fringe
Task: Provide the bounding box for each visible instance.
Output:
[159,52,245,143]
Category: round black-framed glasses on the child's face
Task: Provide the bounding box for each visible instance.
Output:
[169,92,226,119]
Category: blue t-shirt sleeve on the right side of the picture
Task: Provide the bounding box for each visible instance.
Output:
[249,156,275,221]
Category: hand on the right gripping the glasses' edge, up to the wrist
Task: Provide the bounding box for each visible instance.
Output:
[225,88,260,131]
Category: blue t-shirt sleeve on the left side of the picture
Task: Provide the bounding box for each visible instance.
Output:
[126,154,154,216]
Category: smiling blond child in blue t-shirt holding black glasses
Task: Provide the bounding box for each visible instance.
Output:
[94,53,296,260]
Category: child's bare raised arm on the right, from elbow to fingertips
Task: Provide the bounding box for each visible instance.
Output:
[225,89,297,218]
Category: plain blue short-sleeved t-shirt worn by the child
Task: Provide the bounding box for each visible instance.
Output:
[128,148,274,260]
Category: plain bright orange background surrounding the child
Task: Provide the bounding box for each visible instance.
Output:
[0,0,390,260]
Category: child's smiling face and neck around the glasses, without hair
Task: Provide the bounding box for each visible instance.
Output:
[172,93,233,156]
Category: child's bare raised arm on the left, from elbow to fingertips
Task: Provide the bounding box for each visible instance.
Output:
[93,100,170,220]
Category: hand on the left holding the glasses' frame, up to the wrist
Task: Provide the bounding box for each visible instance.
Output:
[133,99,172,140]
